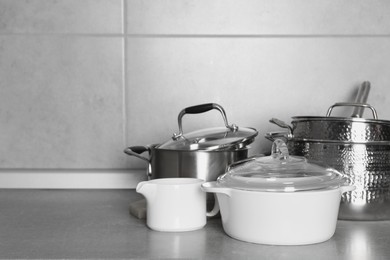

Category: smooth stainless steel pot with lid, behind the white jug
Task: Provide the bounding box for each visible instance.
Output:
[124,103,257,181]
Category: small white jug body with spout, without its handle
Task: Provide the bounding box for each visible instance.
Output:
[136,178,207,232]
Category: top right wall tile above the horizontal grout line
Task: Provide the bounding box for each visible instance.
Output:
[128,0,390,36]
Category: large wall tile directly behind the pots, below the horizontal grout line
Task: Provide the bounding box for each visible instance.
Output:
[127,37,390,158]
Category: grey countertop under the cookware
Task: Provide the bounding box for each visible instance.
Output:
[0,190,390,260]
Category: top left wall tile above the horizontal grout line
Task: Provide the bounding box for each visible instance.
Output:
[0,0,123,34]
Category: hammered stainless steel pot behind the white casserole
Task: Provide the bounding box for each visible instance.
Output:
[266,103,390,220]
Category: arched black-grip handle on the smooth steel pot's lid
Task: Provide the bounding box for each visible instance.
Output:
[172,103,238,140]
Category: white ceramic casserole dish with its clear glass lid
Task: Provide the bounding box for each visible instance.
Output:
[202,140,355,245]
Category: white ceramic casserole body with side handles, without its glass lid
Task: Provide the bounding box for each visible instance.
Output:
[202,182,355,245]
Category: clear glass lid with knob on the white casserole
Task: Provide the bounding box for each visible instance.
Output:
[217,139,345,192]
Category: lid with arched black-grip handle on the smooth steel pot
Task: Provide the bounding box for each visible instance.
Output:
[157,103,258,151]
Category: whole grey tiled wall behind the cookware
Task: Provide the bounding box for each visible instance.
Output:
[0,0,390,187]
